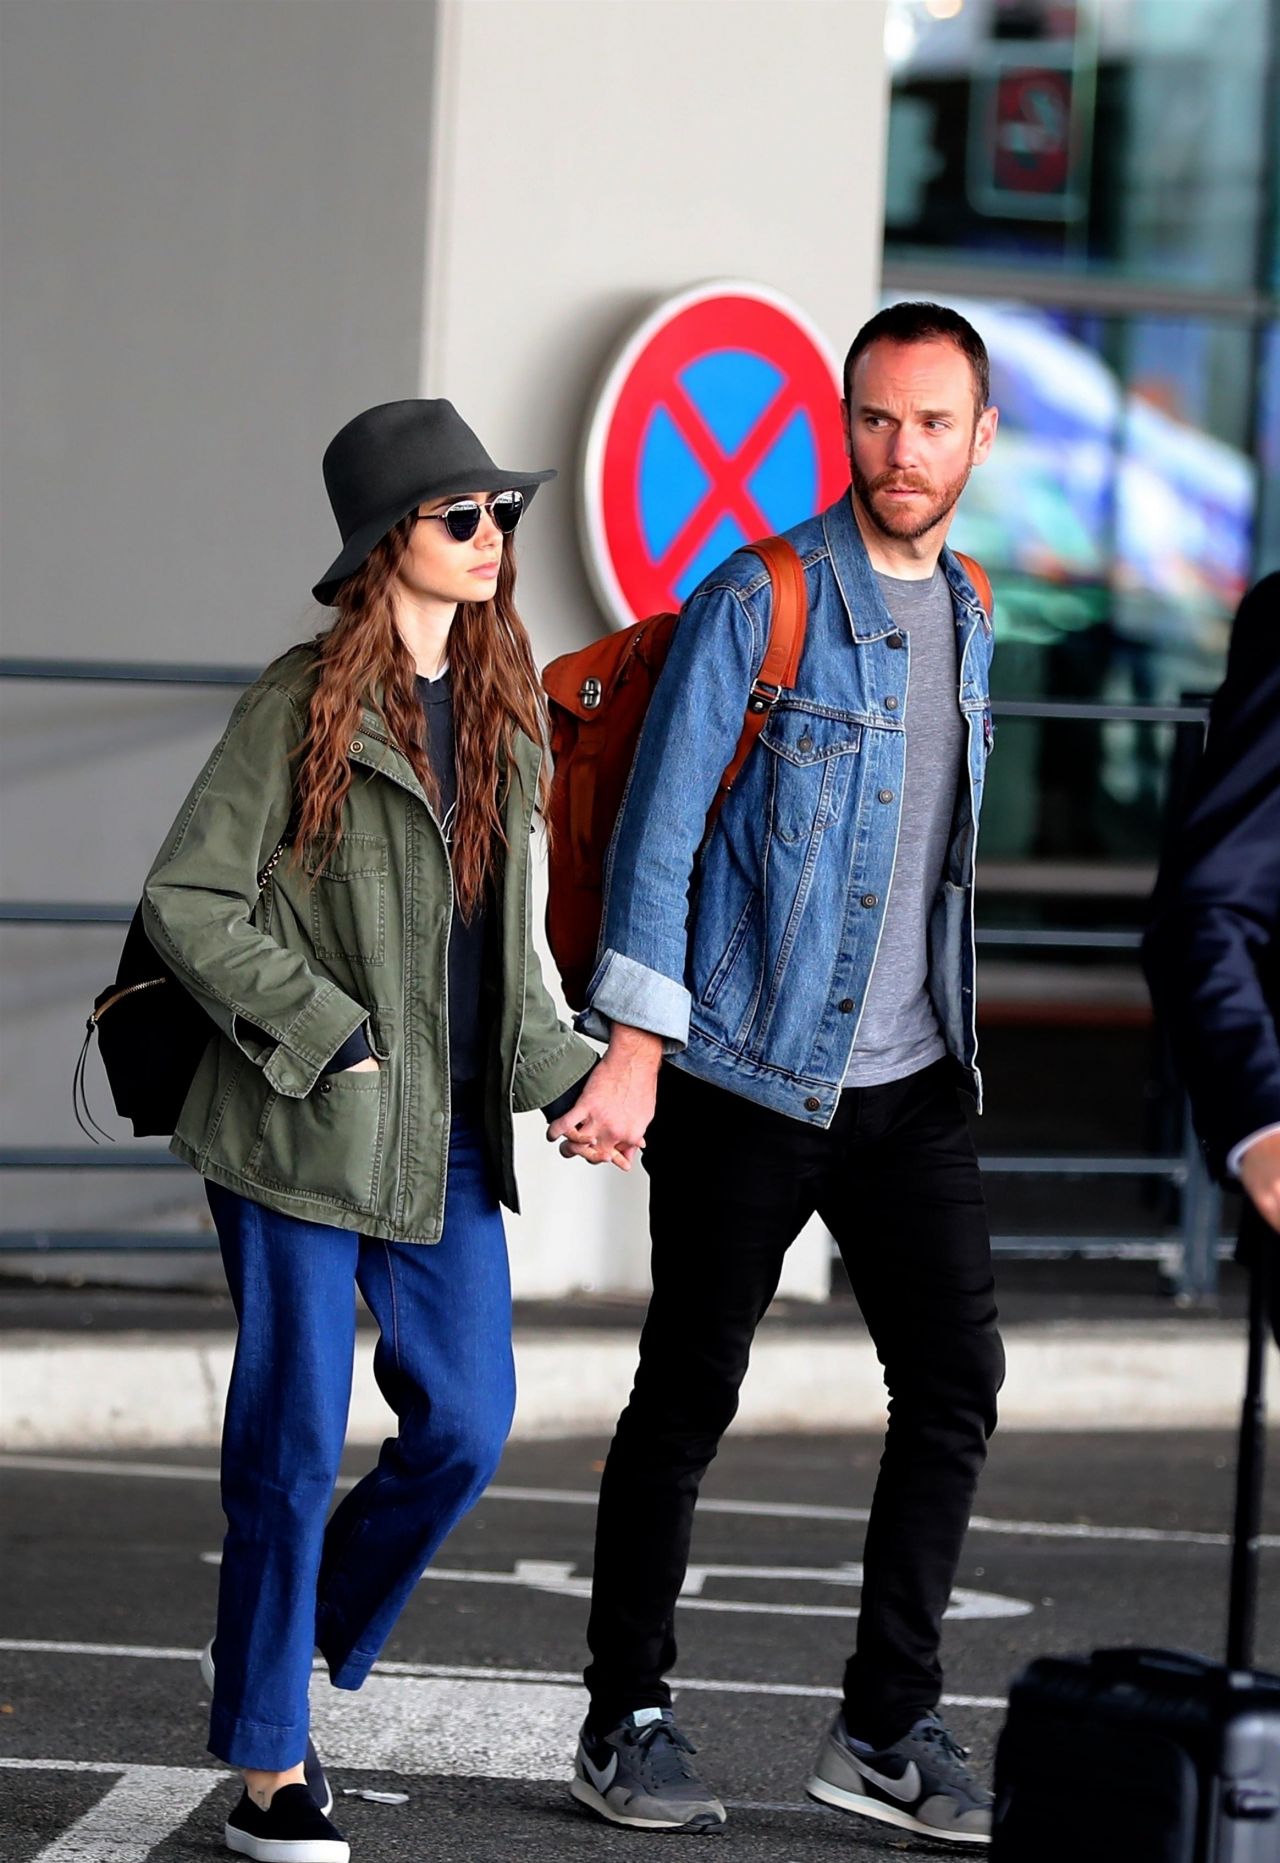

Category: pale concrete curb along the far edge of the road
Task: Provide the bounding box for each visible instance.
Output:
[0,1321,1245,1449]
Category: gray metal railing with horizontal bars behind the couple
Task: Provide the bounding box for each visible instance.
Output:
[0,658,1232,1300]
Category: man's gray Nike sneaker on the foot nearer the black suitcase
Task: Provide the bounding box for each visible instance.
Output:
[805,1714,993,1844]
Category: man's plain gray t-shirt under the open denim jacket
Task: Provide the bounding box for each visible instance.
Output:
[844,568,965,1086]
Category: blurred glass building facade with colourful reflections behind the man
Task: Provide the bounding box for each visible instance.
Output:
[883,0,1280,1235]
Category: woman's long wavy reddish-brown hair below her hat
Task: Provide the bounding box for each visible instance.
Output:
[294,516,551,918]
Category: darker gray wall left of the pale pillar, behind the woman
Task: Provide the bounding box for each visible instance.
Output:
[0,0,436,1266]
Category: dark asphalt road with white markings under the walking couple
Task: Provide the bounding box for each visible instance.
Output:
[0,1435,1280,1863]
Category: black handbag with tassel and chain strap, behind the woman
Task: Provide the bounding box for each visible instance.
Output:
[71,816,296,1144]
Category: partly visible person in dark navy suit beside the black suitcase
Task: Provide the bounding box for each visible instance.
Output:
[1142,574,1280,1339]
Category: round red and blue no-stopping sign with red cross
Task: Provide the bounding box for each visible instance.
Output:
[583,285,848,626]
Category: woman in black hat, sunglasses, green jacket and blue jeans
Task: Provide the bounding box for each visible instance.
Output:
[143,401,596,1863]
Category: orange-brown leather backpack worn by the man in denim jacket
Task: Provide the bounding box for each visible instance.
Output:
[542,537,807,1010]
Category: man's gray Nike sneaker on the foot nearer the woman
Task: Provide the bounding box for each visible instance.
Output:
[570,1708,725,1831]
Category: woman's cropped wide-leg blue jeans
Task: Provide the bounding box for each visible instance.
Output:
[207,1114,516,1772]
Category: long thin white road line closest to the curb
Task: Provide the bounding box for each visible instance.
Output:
[0,1453,1280,1552]
